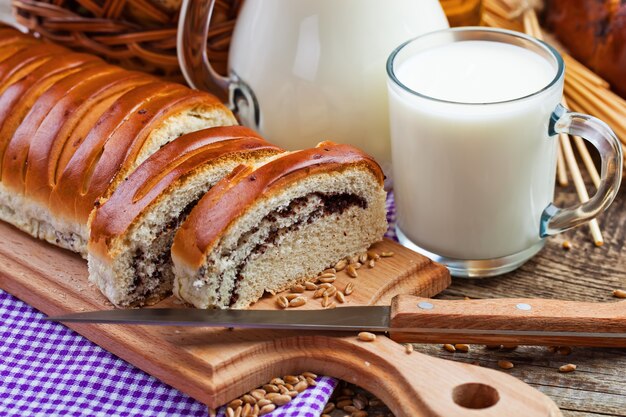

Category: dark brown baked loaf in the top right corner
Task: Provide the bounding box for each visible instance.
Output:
[543,0,626,97]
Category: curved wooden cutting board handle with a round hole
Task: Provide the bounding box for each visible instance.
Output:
[225,334,561,417]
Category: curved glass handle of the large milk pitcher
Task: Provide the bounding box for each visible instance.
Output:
[176,0,231,100]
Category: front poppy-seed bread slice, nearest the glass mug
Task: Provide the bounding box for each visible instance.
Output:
[172,142,387,308]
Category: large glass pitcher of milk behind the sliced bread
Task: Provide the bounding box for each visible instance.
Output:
[178,0,448,180]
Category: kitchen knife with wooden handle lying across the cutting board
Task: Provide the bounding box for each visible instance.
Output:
[49,295,626,347]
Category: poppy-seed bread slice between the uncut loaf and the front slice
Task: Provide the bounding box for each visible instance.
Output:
[88,126,282,307]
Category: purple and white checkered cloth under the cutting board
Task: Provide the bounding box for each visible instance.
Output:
[0,194,395,417]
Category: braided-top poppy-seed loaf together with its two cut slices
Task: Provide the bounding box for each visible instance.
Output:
[0,24,387,308]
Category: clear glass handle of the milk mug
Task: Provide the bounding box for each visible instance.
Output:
[540,104,623,238]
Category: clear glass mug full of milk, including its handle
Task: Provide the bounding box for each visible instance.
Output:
[387,27,622,277]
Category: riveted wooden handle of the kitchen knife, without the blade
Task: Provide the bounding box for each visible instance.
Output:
[390,295,626,347]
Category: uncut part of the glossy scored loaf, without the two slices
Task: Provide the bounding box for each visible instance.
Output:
[0,27,236,257]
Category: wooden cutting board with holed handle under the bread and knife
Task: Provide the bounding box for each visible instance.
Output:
[0,222,560,417]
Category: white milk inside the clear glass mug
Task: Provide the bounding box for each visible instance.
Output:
[389,41,561,260]
